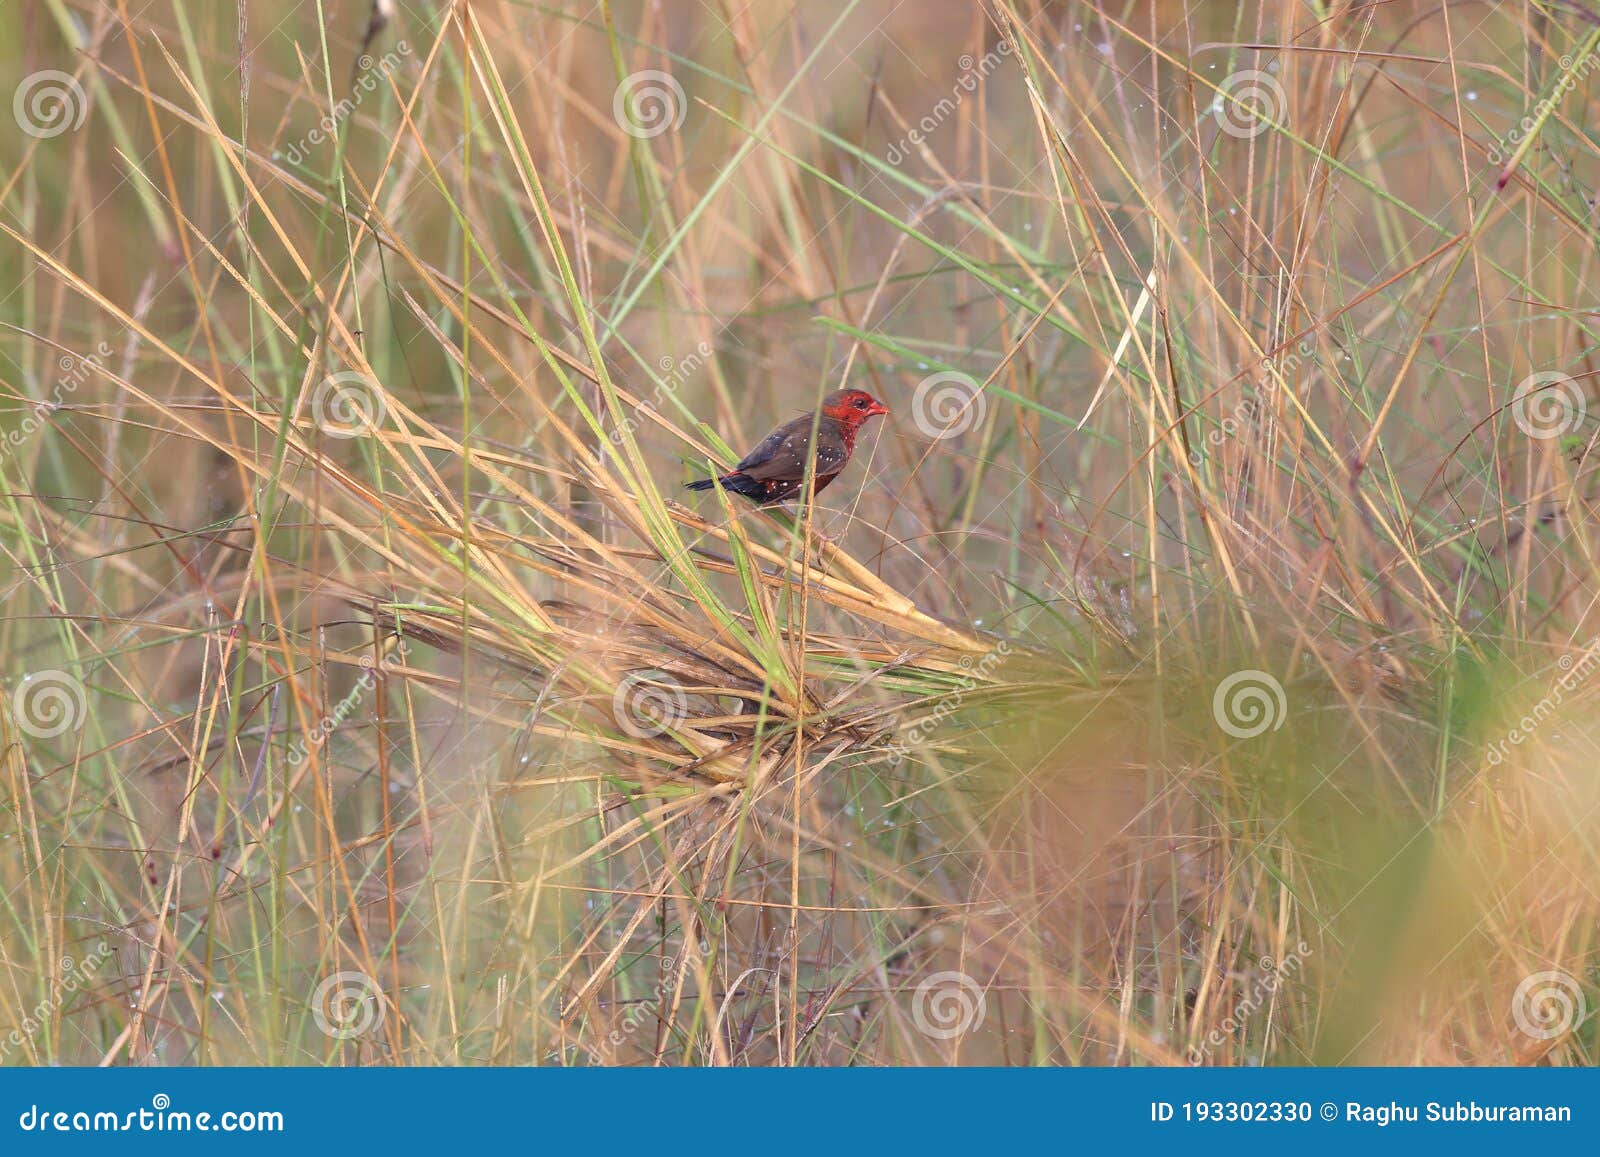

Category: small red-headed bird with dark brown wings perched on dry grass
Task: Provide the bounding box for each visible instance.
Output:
[688,389,890,506]
